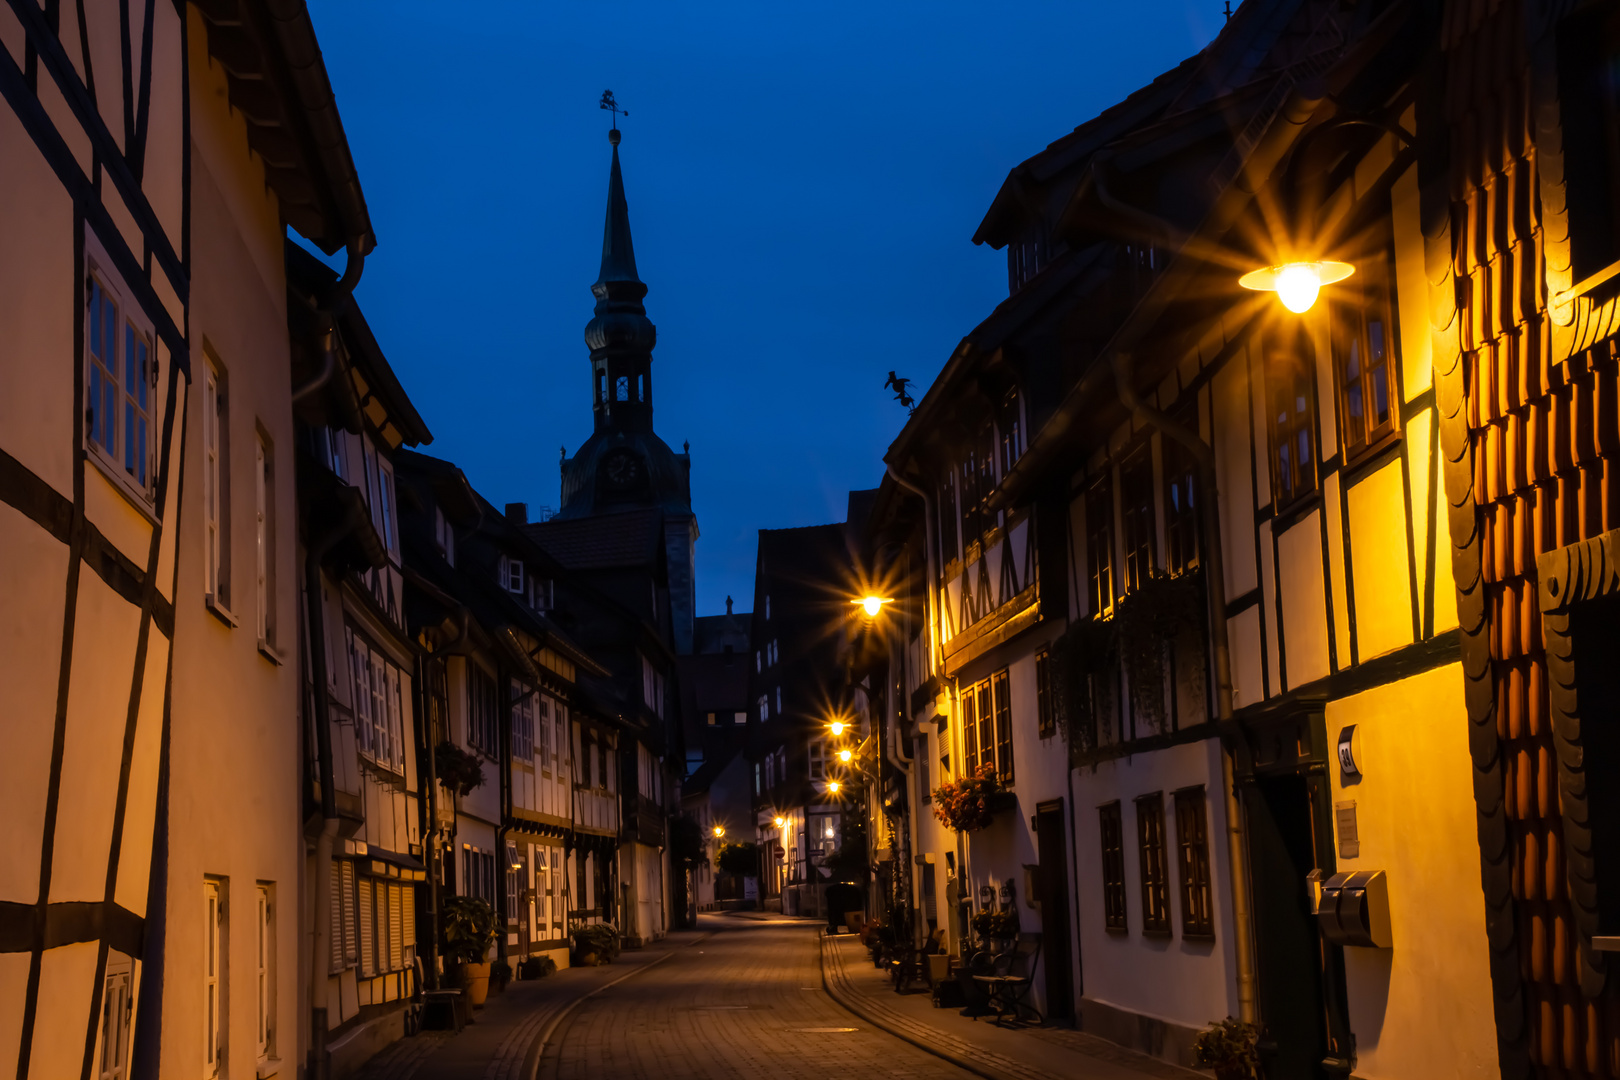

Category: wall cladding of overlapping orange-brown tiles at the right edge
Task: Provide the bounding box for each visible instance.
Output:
[1421,0,1620,1078]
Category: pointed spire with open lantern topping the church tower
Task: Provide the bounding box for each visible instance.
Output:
[585,123,658,431]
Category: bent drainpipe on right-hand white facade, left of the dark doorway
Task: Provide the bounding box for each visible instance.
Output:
[1111,351,1257,1023]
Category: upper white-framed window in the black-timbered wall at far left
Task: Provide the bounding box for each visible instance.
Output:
[84,236,157,512]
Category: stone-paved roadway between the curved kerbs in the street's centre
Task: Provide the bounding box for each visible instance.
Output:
[539,918,972,1080]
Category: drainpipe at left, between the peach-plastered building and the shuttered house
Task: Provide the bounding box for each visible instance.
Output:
[305,504,360,1080]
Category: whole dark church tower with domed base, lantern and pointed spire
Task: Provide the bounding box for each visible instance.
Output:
[556,126,698,653]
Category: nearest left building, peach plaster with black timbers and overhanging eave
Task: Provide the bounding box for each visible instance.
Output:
[0,0,374,1077]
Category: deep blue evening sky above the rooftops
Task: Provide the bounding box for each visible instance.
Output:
[301,0,1221,614]
